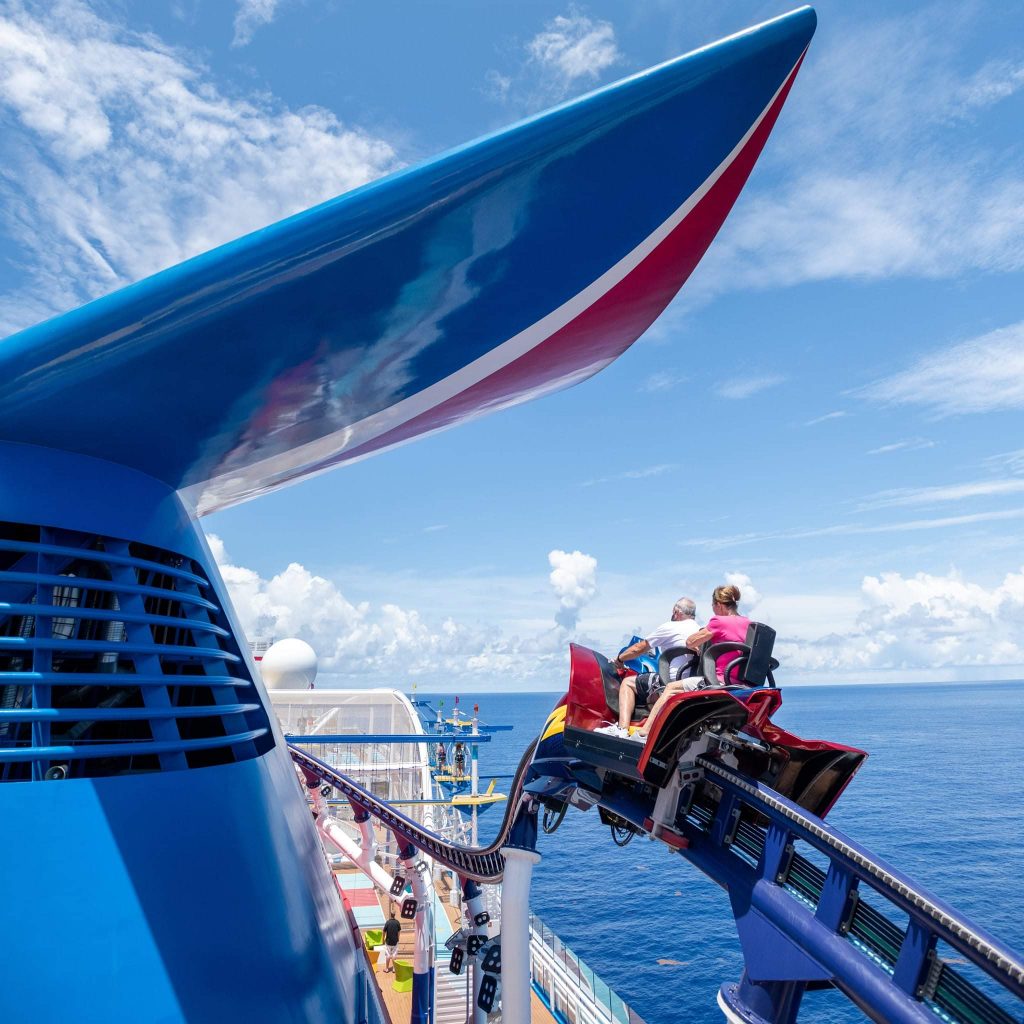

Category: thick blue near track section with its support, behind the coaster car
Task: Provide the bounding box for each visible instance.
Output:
[679,759,1024,1024]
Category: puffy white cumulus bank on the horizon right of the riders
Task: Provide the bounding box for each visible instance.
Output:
[781,568,1024,679]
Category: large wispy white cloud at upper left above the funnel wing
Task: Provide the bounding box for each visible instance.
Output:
[0,0,397,330]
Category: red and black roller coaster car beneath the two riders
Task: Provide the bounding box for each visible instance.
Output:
[564,624,867,816]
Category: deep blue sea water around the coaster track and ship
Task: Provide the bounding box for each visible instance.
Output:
[421,683,1024,1024]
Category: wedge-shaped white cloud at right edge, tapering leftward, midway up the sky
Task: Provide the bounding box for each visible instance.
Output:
[857,321,1024,416]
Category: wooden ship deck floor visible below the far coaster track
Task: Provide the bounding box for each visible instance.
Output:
[335,869,557,1024]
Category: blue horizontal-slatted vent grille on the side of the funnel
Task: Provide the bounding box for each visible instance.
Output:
[0,522,273,781]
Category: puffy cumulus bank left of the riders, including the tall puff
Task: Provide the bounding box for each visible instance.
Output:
[207,535,597,687]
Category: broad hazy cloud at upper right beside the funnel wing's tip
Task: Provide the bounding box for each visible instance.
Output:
[688,12,1024,302]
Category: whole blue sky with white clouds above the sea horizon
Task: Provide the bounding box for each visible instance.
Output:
[0,0,1024,689]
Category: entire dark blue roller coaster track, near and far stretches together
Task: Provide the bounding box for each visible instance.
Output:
[291,742,1024,1024]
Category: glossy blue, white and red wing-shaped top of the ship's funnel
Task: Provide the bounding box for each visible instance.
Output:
[0,8,815,514]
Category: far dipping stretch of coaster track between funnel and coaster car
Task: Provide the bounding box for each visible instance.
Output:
[289,740,537,884]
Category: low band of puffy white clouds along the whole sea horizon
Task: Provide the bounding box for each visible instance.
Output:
[208,535,1024,689]
